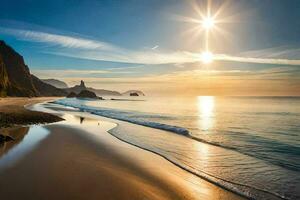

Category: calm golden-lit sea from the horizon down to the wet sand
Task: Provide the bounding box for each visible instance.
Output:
[58,96,300,199]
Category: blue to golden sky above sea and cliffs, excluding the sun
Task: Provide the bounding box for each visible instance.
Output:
[0,0,300,95]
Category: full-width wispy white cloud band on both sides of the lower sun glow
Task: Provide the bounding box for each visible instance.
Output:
[0,27,300,66]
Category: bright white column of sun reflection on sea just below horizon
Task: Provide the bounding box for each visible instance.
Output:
[197,96,215,131]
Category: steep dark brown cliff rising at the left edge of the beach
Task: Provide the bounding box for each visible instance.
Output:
[0,40,66,97]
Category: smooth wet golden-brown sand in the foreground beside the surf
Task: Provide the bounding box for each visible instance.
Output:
[0,100,242,200]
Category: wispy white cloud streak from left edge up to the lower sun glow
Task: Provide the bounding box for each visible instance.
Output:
[0,27,199,64]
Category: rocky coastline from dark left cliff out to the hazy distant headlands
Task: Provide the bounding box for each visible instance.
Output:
[0,40,145,97]
